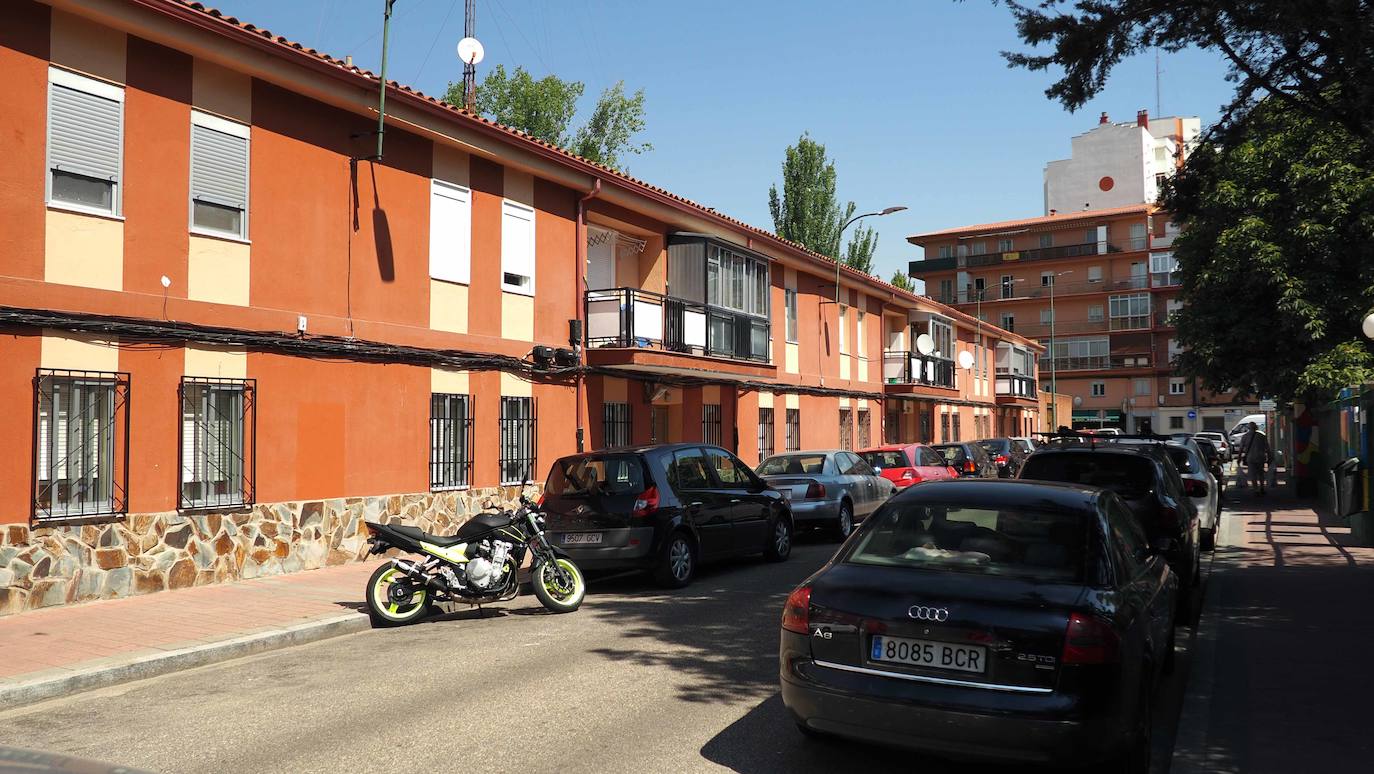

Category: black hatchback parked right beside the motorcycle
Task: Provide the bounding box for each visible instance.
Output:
[541,444,793,587]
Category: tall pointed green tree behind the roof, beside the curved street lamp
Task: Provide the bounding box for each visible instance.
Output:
[768,132,878,272]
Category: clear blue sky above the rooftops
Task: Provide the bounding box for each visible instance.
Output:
[210,0,1231,279]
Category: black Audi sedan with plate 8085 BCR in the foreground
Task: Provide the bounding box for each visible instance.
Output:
[779,480,1178,773]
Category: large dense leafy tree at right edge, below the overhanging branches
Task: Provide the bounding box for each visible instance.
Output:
[1161,98,1374,399]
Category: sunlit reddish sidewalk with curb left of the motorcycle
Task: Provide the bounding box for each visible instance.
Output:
[0,561,378,708]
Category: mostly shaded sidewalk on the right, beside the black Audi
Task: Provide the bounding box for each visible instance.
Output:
[1171,488,1374,774]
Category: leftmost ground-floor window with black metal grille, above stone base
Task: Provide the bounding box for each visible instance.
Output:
[33,368,129,521]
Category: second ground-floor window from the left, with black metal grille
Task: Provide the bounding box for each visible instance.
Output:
[177,377,257,510]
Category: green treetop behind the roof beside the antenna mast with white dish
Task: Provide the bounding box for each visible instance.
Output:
[444,65,653,168]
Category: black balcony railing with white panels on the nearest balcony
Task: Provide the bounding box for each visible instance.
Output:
[587,287,772,363]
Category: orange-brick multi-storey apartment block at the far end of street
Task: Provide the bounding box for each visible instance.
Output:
[908,203,1237,432]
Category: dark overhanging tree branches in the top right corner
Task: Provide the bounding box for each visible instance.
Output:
[993,0,1374,146]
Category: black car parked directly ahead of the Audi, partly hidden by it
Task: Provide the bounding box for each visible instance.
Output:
[1021,440,1202,621]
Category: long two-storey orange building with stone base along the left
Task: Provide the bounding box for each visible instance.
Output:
[0,0,1040,615]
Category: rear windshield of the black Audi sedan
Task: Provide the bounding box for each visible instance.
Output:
[844,500,1091,582]
